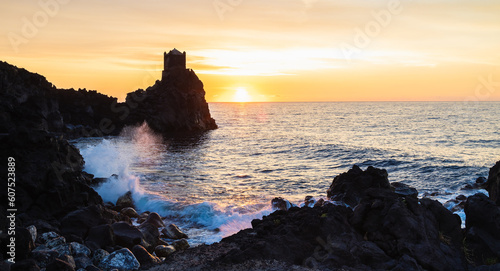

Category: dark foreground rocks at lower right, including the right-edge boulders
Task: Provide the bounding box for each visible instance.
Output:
[152,167,500,270]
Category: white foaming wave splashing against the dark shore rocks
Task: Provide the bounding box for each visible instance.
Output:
[77,124,272,245]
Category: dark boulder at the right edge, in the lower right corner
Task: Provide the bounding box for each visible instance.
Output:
[464,193,500,265]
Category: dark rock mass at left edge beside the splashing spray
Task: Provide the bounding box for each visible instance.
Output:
[0,130,102,236]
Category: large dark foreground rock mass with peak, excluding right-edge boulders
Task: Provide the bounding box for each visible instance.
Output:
[221,168,466,270]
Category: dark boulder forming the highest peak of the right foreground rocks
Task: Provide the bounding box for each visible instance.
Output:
[326,165,391,207]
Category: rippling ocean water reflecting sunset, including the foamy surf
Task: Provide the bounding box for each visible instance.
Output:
[74,102,500,245]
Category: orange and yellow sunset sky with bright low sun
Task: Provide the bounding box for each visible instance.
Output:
[0,0,500,102]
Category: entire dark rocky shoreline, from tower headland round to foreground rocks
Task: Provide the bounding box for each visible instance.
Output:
[0,62,500,271]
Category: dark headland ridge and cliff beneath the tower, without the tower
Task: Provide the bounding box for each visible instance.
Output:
[0,59,217,138]
